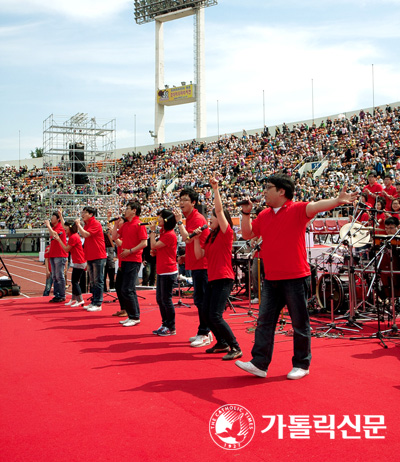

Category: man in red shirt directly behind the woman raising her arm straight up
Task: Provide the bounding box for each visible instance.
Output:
[175,188,212,347]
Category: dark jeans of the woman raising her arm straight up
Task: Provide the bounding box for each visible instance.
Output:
[204,279,239,348]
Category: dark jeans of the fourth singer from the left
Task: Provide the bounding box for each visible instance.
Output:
[115,261,140,320]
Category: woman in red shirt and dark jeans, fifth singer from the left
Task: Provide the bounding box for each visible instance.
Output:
[149,209,178,337]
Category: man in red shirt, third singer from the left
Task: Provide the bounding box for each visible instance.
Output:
[75,206,107,311]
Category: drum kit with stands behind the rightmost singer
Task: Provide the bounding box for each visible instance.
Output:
[309,212,400,347]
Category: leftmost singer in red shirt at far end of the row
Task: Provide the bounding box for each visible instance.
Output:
[44,212,68,303]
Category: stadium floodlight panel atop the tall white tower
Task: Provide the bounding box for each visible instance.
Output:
[134,0,218,24]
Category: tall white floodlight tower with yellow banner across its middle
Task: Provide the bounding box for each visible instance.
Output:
[135,0,218,144]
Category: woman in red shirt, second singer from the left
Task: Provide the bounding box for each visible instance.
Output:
[53,222,87,308]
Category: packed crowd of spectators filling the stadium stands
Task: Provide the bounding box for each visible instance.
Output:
[0,102,400,229]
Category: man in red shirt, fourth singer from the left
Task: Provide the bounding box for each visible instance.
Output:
[112,201,147,327]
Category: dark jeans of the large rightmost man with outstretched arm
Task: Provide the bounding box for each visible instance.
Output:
[251,276,311,371]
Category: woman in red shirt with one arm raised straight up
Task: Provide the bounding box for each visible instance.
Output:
[194,178,242,361]
